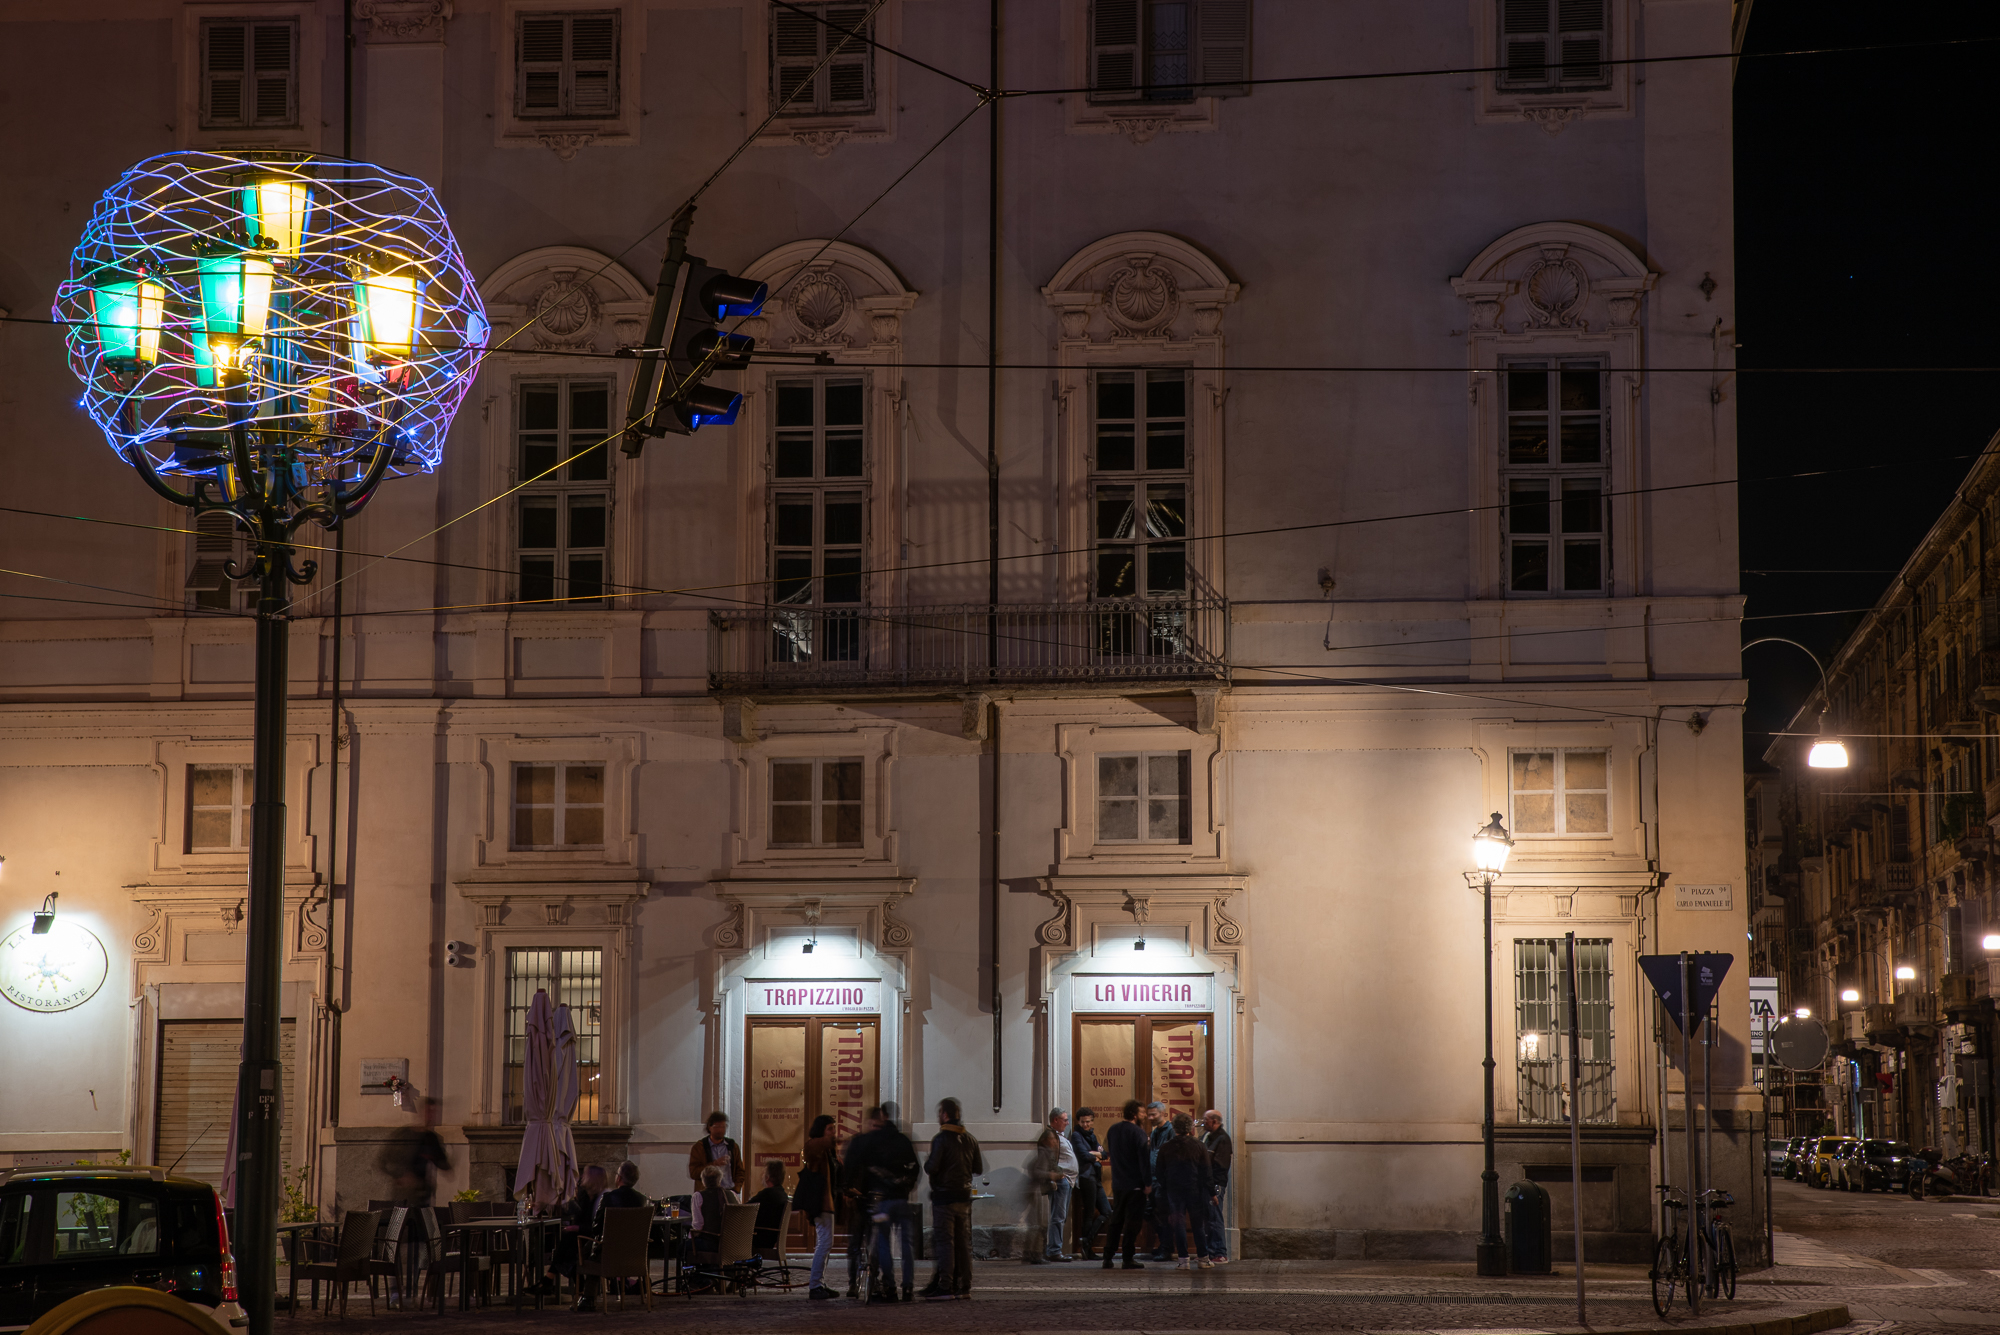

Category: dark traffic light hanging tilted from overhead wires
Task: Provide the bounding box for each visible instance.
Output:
[620,206,766,456]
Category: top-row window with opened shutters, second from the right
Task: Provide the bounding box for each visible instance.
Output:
[1090,0,1250,102]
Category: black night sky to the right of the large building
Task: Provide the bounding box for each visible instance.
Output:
[1736,0,2000,757]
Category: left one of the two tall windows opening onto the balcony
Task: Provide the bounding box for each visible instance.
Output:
[770,376,868,664]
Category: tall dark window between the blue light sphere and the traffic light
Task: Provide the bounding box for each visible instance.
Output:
[514,375,612,608]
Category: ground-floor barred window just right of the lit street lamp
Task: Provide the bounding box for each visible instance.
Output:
[1514,937,1618,1125]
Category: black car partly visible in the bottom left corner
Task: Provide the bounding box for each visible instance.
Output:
[0,1167,246,1331]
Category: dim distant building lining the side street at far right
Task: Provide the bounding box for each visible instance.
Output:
[1750,437,2000,1153]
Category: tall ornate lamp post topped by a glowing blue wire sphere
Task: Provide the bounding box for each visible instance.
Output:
[54,152,486,1335]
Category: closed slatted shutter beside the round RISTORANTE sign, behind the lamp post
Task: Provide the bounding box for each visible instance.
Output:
[152,1019,298,1185]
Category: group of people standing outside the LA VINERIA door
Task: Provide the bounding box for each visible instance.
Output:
[1022,1099,1236,1269]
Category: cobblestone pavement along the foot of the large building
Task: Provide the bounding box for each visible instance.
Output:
[254,1183,2000,1335]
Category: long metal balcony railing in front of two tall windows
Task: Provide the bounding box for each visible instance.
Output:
[708,598,1230,691]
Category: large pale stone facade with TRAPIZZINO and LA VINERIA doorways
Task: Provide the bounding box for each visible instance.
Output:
[0,0,1760,1259]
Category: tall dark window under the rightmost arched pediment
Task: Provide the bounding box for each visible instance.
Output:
[1500,362,1610,594]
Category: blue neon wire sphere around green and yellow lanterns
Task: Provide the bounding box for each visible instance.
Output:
[54,152,490,484]
